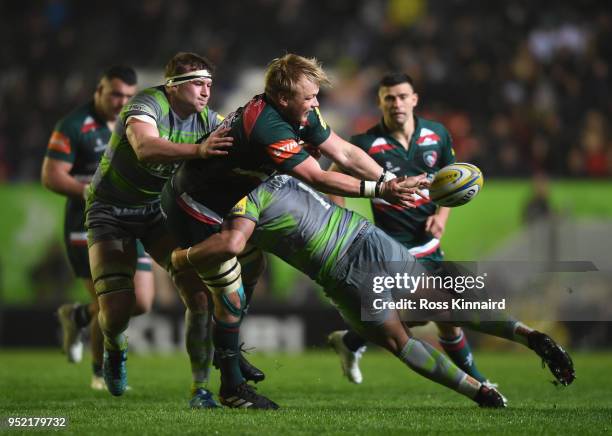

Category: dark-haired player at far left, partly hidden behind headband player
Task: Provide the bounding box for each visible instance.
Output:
[41,66,154,390]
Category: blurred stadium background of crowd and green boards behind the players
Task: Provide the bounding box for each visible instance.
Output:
[0,0,612,352]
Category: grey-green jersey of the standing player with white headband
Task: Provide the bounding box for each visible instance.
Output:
[90,86,223,207]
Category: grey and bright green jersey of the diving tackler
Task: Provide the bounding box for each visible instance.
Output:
[230,175,368,286]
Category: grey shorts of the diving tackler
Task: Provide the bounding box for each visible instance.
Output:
[325,226,422,331]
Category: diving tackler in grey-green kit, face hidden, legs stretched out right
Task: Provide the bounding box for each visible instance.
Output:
[172,175,574,407]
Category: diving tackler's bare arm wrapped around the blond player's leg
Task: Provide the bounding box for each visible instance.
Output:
[172,218,255,271]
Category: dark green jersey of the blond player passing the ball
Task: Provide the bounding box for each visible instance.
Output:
[172,95,331,221]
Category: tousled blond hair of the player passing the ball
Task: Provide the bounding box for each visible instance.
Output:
[265,53,331,98]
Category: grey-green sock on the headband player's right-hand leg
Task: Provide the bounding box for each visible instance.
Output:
[185,309,214,394]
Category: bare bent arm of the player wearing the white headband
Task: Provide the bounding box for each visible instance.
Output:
[126,118,233,163]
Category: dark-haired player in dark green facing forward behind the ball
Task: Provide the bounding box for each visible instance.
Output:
[328,72,489,383]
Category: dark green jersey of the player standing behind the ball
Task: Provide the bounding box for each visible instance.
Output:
[350,116,455,258]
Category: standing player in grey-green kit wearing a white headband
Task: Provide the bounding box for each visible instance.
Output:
[86,53,249,408]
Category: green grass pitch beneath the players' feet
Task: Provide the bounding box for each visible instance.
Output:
[0,351,612,436]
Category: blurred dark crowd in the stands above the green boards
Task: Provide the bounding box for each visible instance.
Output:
[0,0,612,181]
